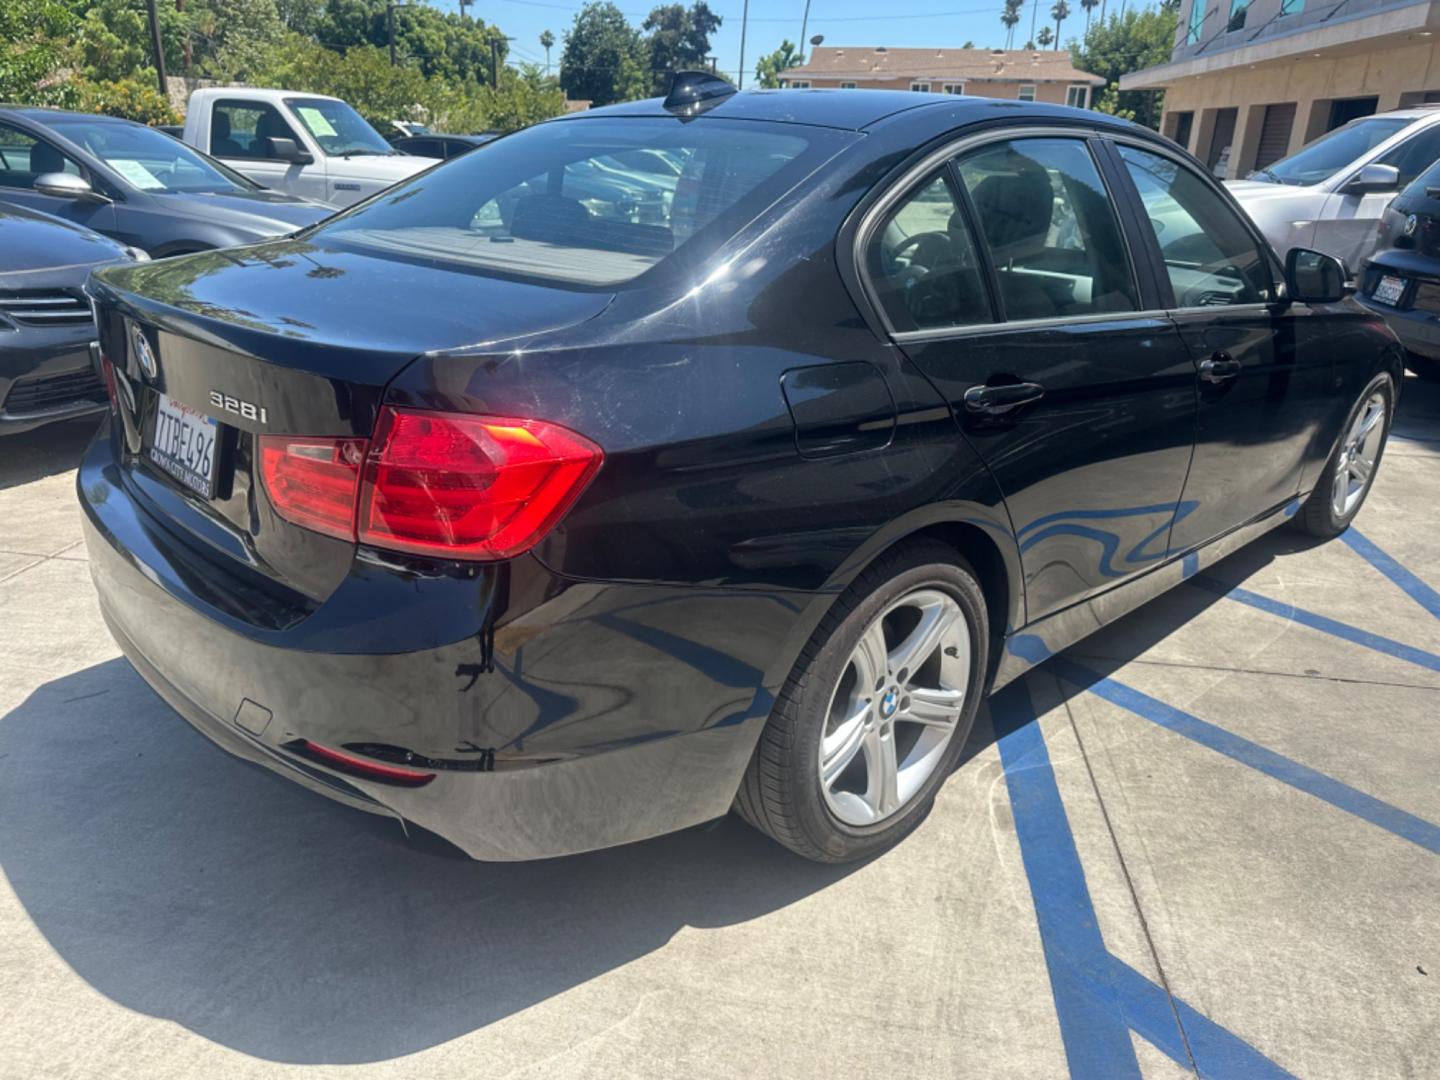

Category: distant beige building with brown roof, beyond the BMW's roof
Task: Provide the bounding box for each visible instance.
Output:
[780,45,1104,108]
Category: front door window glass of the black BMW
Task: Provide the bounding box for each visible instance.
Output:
[1119,145,1273,308]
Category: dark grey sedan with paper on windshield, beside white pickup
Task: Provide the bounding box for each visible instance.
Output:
[0,108,334,259]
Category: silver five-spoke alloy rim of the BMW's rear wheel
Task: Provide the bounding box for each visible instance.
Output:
[818,589,971,827]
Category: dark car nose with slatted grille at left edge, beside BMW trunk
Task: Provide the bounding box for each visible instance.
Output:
[0,203,136,435]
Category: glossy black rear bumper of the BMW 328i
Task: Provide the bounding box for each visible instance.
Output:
[78,433,819,860]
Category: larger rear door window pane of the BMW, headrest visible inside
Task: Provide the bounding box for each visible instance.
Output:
[959,138,1138,320]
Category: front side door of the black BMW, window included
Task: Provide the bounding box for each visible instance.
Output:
[1116,144,1331,552]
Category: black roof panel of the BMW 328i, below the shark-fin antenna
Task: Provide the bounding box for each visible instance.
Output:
[550,89,1135,131]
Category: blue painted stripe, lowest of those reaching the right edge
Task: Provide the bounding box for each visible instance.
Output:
[1051,657,1440,855]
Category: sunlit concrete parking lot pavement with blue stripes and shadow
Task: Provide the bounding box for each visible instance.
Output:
[0,380,1440,1079]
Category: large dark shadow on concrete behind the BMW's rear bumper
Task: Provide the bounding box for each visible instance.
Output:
[0,660,848,1063]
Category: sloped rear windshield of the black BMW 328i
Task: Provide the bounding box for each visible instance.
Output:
[303,117,847,288]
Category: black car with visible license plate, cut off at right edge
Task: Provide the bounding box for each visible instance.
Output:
[1359,156,1440,379]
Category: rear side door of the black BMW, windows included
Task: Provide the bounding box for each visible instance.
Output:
[864,134,1195,621]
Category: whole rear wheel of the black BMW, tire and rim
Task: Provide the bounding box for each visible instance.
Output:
[736,540,989,863]
